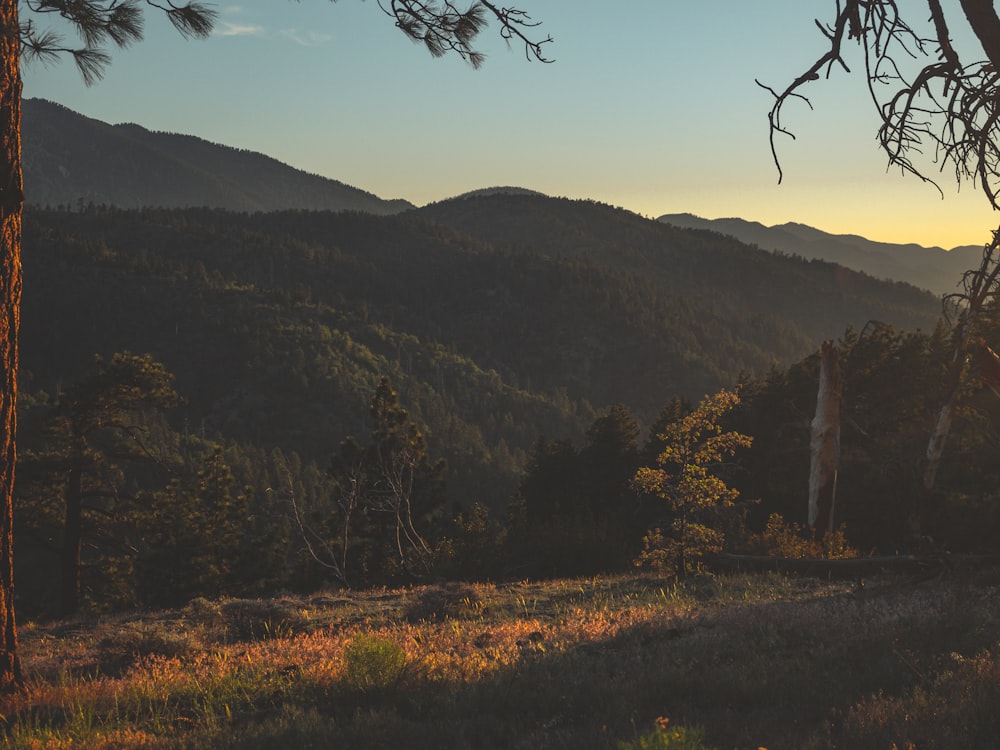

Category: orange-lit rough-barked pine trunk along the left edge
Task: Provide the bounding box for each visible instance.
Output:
[0,0,24,692]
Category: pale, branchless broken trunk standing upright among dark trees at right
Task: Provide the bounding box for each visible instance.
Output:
[809,341,844,539]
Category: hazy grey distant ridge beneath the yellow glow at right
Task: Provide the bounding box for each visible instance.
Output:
[658,214,982,294]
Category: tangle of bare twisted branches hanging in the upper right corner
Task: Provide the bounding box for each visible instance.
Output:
[758,0,1000,208]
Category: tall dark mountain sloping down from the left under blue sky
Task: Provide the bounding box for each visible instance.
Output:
[22,99,413,215]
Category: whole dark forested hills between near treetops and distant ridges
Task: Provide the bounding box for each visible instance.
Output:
[23,200,938,503]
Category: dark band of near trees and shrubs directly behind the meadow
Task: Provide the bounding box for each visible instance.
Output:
[16,312,1000,619]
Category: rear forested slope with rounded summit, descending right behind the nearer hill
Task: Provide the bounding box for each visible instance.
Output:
[415,195,939,340]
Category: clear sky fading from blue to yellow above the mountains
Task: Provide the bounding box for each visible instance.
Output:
[22,0,1000,253]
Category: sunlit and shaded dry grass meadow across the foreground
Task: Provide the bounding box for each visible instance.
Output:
[0,575,1000,750]
